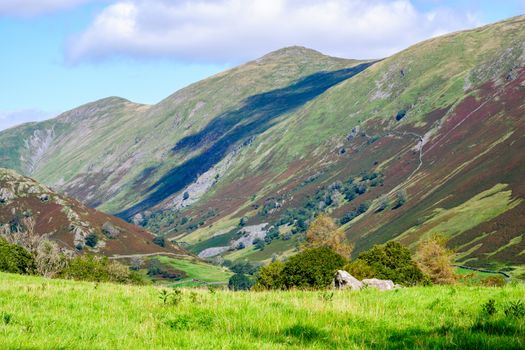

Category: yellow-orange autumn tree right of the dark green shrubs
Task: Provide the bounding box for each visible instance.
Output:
[416,235,458,284]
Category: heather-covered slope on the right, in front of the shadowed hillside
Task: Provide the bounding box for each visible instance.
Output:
[165,17,525,264]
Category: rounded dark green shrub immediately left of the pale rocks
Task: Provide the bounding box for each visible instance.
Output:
[282,247,346,289]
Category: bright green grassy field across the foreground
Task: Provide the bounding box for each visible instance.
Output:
[0,274,525,349]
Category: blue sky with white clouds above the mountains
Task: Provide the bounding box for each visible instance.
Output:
[0,0,525,130]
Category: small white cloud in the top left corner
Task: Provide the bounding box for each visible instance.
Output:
[0,0,102,17]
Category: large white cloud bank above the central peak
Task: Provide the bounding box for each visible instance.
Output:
[67,0,480,63]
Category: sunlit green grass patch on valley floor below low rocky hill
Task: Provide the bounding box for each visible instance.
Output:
[158,256,232,282]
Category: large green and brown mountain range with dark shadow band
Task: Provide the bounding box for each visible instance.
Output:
[0,16,525,266]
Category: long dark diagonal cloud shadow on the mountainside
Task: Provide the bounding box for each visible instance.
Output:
[117,63,373,218]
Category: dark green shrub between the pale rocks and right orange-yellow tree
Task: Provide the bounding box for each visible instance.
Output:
[350,241,430,285]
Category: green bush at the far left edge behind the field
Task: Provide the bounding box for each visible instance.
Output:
[0,238,36,274]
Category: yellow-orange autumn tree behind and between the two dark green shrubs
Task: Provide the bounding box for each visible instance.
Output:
[306,214,354,258]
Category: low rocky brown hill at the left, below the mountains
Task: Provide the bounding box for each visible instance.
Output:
[0,169,189,256]
